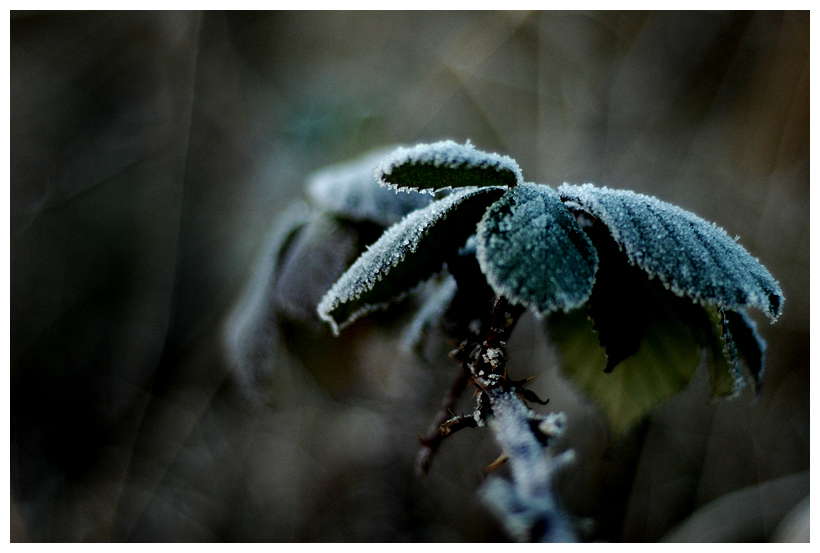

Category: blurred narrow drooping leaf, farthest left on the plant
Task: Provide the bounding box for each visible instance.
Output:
[223,202,315,389]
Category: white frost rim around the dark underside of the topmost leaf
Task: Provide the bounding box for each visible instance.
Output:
[373,139,524,194]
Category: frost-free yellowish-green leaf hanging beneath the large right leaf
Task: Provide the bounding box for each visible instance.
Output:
[547,280,705,433]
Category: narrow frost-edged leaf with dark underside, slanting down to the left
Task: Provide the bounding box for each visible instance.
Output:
[318,187,504,334]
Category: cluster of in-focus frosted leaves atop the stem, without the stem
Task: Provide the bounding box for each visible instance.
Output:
[318,141,783,431]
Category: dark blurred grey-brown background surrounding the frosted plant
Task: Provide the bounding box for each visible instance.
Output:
[10,12,809,541]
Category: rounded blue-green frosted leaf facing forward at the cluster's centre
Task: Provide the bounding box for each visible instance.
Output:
[477,183,598,315]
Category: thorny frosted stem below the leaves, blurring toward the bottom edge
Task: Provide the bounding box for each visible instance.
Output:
[418,296,576,541]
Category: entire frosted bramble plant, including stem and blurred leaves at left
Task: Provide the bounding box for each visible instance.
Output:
[227,141,783,541]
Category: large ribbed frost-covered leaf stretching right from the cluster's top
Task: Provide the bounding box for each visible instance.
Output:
[558,184,783,321]
